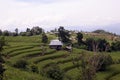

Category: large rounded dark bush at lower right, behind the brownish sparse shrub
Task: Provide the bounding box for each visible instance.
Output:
[89,53,113,71]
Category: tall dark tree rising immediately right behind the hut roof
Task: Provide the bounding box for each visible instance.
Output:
[58,26,70,43]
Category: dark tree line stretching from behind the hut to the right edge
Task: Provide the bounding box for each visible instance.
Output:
[58,26,120,52]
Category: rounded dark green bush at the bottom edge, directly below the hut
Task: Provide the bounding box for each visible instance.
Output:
[45,64,64,80]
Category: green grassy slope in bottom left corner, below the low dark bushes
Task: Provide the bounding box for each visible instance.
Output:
[4,66,49,80]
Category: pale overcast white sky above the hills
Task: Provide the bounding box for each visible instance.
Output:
[0,0,120,33]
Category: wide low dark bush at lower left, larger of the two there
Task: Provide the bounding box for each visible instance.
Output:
[13,59,28,69]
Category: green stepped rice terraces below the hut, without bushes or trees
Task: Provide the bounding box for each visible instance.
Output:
[4,37,120,80]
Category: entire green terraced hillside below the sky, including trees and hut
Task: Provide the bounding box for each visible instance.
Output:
[1,27,120,80]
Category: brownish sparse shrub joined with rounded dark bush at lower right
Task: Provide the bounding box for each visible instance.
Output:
[74,53,113,80]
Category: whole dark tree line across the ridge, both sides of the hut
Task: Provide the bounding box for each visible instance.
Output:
[0,26,120,52]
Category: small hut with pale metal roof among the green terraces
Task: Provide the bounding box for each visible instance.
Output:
[49,39,63,50]
